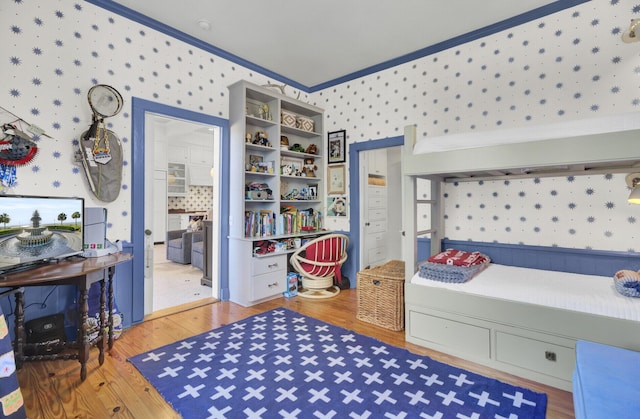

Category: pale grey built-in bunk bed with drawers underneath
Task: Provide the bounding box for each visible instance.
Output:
[403,115,640,390]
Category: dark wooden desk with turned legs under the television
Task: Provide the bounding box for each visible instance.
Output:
[0,252,133,381]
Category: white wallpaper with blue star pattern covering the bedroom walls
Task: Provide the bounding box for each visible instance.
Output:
[5,0,640,251]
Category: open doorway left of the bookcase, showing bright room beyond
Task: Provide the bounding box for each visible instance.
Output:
[145,112,220,313]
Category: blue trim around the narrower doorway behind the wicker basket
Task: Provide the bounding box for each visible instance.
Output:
[349,136,404,277]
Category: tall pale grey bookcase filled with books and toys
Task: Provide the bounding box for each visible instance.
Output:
[229,81,326,305]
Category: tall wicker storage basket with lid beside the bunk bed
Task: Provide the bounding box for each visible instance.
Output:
[356,260,404,331]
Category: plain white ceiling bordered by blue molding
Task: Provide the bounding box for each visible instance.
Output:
[110,0,568,88]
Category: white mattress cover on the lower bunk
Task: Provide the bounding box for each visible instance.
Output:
[411,263,640,321]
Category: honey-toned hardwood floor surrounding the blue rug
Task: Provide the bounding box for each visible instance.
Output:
[18,290,574,419]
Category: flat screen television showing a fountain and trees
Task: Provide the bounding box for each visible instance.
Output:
[0,195,84,273]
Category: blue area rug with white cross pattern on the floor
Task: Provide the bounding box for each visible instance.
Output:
[129,309,547,419]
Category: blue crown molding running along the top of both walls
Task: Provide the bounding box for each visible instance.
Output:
[85,0,591,93]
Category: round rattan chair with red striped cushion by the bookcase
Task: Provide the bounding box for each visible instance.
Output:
[290,234,349,298]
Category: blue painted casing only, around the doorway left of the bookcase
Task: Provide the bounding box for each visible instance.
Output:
[131,97,230,322]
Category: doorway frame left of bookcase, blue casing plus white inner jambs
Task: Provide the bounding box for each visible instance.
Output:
[131,97,229,322]
